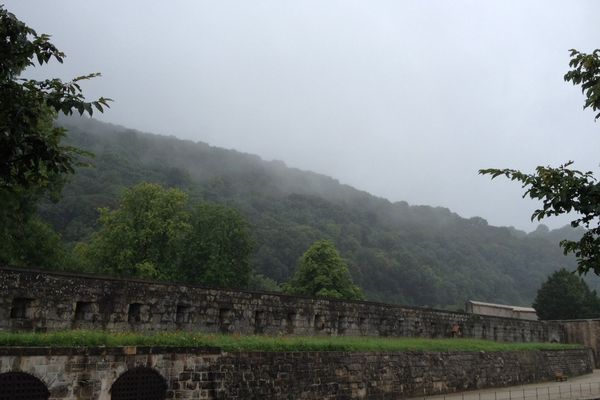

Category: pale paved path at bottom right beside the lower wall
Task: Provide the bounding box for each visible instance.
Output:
[414,369,600,400]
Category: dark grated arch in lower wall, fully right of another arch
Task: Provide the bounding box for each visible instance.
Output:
[110,367,167,400]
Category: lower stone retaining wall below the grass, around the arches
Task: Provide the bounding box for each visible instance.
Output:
[0,347,593,400]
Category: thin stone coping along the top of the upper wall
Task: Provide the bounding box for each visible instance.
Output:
[0,264,542,322]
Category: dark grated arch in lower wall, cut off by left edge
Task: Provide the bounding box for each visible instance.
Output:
[0,371,50,400]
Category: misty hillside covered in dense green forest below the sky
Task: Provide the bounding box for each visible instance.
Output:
[39,118,584,308]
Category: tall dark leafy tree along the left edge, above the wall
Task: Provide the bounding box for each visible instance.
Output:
[0,5,110,268]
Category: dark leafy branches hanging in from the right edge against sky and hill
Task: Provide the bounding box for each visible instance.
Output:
[479,49,600,275]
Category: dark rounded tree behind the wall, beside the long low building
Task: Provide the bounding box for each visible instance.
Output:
[533,268,600,319]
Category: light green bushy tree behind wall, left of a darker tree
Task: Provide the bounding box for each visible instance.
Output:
[77,183,191,279]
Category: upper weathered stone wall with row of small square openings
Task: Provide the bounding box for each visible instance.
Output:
[0,268,559,342]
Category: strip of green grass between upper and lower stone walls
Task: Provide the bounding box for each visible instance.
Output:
[0,330,582,351]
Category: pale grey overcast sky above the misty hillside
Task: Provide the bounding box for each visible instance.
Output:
[4,0,600,230]
